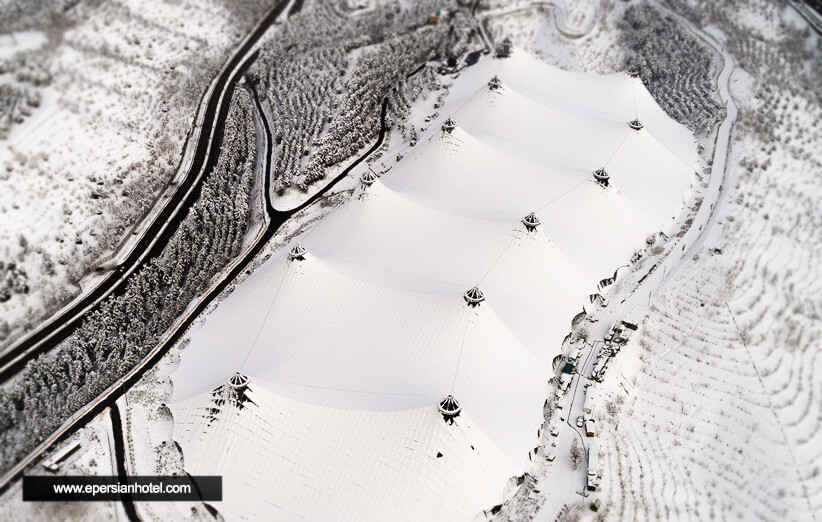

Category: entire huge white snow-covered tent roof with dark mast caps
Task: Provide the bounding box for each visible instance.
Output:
[171,46,696,520]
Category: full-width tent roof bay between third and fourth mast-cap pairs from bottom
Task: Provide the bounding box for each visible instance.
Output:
[381,125,692,282]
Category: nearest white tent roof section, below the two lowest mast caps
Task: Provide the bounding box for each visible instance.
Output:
[174,390,533,521]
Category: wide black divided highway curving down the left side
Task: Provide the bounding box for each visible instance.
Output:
[0,0,293,383]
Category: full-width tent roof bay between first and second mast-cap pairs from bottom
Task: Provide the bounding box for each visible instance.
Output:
[174,255,547,414]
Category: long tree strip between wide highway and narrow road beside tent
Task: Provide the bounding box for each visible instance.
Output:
[0,90,256,470]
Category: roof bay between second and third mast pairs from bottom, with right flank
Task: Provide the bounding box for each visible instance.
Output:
[305,183,595,365]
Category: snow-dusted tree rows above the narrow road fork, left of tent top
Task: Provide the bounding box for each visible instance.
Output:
[254,0,468,193]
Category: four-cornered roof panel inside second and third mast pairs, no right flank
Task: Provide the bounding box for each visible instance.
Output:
[305,182,521,292]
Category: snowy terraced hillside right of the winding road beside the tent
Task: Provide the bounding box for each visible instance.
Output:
[599,0,822,520]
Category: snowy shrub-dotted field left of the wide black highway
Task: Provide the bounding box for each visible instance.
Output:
[0,0,270,350]
